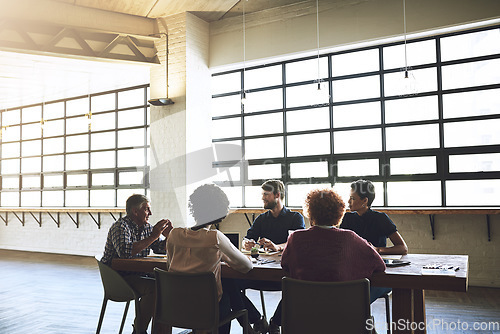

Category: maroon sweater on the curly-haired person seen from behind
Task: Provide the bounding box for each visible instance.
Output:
[281,226,385,282]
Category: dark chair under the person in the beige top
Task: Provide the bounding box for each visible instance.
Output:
[152,268,248,334]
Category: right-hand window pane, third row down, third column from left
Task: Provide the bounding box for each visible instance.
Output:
[286,108,330,132]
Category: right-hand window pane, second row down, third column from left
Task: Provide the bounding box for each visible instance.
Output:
[286,82,330,108]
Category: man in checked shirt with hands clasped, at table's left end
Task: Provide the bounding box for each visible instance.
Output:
[101,194,172,334]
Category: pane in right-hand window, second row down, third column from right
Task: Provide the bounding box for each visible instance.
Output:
[332,75,380,102]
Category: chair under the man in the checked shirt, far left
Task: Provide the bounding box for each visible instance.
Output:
[95,256,141,334]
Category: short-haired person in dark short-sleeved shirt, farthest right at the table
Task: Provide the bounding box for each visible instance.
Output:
[340,180,408,302]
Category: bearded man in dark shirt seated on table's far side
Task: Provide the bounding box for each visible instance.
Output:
[241,180,305,334]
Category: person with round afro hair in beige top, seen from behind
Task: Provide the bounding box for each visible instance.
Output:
[167,184,253,334]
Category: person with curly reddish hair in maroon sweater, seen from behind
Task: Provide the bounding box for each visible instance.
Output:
[281,189,385,282]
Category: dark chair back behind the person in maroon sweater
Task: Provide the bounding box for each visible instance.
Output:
[281,277,374,334]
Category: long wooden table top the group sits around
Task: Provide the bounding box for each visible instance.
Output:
[112,254,469,292]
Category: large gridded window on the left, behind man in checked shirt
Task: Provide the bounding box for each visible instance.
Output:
[0,85,149,207]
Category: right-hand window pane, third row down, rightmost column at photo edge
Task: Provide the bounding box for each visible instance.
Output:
[443,89,500,118]
